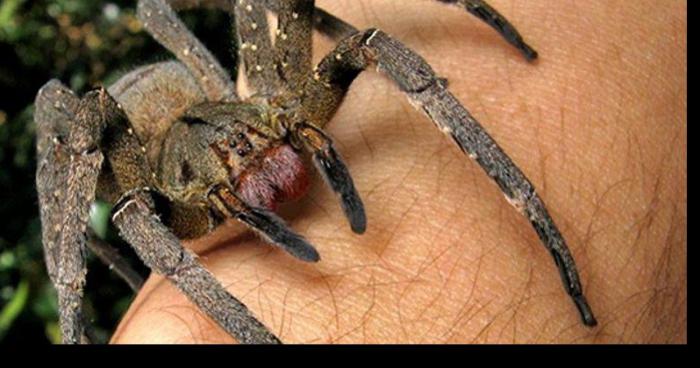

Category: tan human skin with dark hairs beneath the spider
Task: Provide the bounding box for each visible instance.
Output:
[112,0,687,343]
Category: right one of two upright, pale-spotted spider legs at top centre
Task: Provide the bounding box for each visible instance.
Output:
[275,0,314,91]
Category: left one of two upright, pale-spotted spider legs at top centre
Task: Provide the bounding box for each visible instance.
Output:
[234,0,282,95]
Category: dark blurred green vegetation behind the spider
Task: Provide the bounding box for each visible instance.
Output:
[0,0,232,344]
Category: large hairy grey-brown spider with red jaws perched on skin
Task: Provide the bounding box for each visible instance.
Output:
[35,0,596,343]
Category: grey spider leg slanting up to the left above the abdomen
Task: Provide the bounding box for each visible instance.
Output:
[136,0,238,101]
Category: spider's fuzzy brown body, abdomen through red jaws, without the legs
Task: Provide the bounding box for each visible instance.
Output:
[108,62,346,238]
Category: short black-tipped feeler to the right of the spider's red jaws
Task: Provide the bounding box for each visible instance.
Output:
[295,123,367,234]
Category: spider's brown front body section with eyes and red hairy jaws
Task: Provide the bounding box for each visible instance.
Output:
[154,103,309,237]
